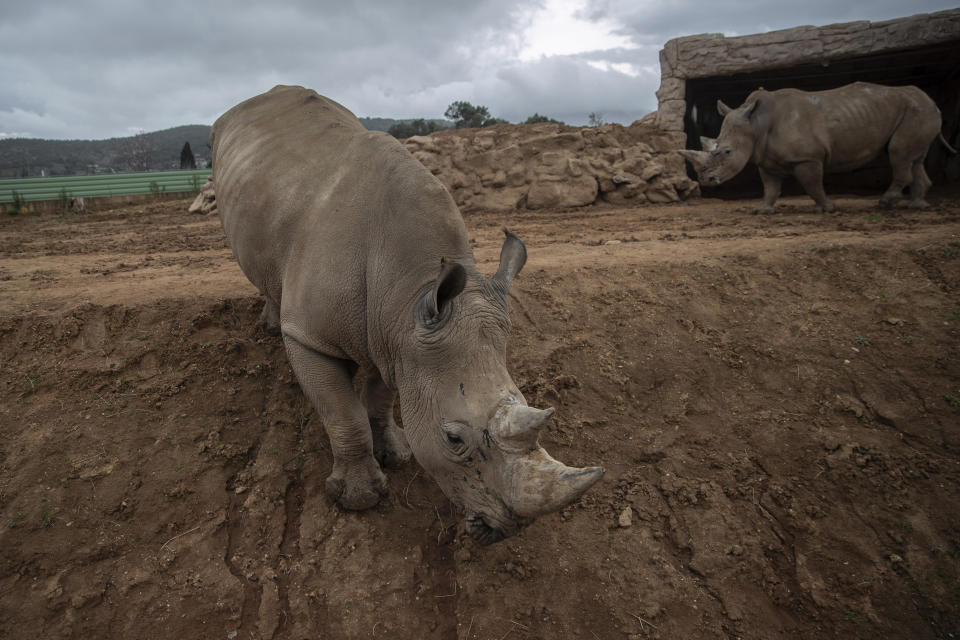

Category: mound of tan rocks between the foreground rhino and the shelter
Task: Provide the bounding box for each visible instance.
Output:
[403,119,699,212]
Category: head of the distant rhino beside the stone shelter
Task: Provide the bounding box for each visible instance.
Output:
[680,97,760,187]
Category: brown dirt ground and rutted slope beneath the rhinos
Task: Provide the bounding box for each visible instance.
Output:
[0,194,960,640]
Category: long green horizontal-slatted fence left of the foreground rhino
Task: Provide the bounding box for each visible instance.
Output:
[0,169,211,203]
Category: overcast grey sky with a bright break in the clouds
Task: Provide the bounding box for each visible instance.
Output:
[0,0,958,139]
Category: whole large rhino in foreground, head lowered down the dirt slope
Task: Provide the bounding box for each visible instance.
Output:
[211,86,604,543]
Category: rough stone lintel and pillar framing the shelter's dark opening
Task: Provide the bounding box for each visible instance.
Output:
[656,9,960,132]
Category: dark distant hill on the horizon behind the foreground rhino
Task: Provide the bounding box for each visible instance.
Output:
[0,118,450,178]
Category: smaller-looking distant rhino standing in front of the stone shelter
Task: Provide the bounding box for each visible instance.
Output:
[680,82,956,213]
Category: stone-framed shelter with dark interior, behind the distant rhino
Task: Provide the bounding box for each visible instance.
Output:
[656,9,960,195]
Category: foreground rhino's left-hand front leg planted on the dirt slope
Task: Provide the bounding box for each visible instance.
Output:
[283,335,387,511]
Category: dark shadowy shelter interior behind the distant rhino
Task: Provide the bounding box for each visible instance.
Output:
[684,40,960,198]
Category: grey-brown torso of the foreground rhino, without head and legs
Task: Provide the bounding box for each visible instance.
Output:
[212,87,473,370]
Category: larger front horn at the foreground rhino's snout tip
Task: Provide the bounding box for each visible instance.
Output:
[508,449,606,518]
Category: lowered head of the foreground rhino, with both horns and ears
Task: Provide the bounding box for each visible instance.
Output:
[397,232,604,544]
